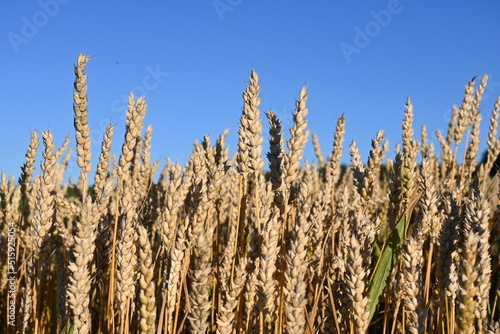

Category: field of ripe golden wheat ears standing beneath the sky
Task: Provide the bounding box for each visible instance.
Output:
[0,54,500,334]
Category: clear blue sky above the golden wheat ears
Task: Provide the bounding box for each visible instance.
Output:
[0,0,500,183]
